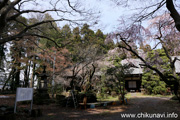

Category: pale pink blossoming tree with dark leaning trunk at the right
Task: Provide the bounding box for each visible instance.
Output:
[107,15,180,101]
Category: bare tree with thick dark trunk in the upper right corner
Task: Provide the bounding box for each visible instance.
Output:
[112,0,180,31]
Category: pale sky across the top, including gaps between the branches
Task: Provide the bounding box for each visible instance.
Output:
[23,0,167,33]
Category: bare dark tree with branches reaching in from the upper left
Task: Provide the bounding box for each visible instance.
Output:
[0,0,97,44]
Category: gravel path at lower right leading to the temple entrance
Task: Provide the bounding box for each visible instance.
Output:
[106,97,180,120]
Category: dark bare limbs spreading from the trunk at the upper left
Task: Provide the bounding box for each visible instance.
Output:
[0,0,97,44]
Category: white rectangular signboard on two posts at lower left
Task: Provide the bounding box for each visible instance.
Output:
[14,88,33,113]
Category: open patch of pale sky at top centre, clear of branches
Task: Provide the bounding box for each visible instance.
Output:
[84,0,129,33]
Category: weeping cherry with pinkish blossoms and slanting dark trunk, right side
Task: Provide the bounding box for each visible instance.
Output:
[109,13,180,101]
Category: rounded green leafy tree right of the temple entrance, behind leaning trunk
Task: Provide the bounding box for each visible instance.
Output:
[142,49,170,94]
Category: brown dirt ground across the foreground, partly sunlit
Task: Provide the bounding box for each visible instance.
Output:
[0,93,180,120]
